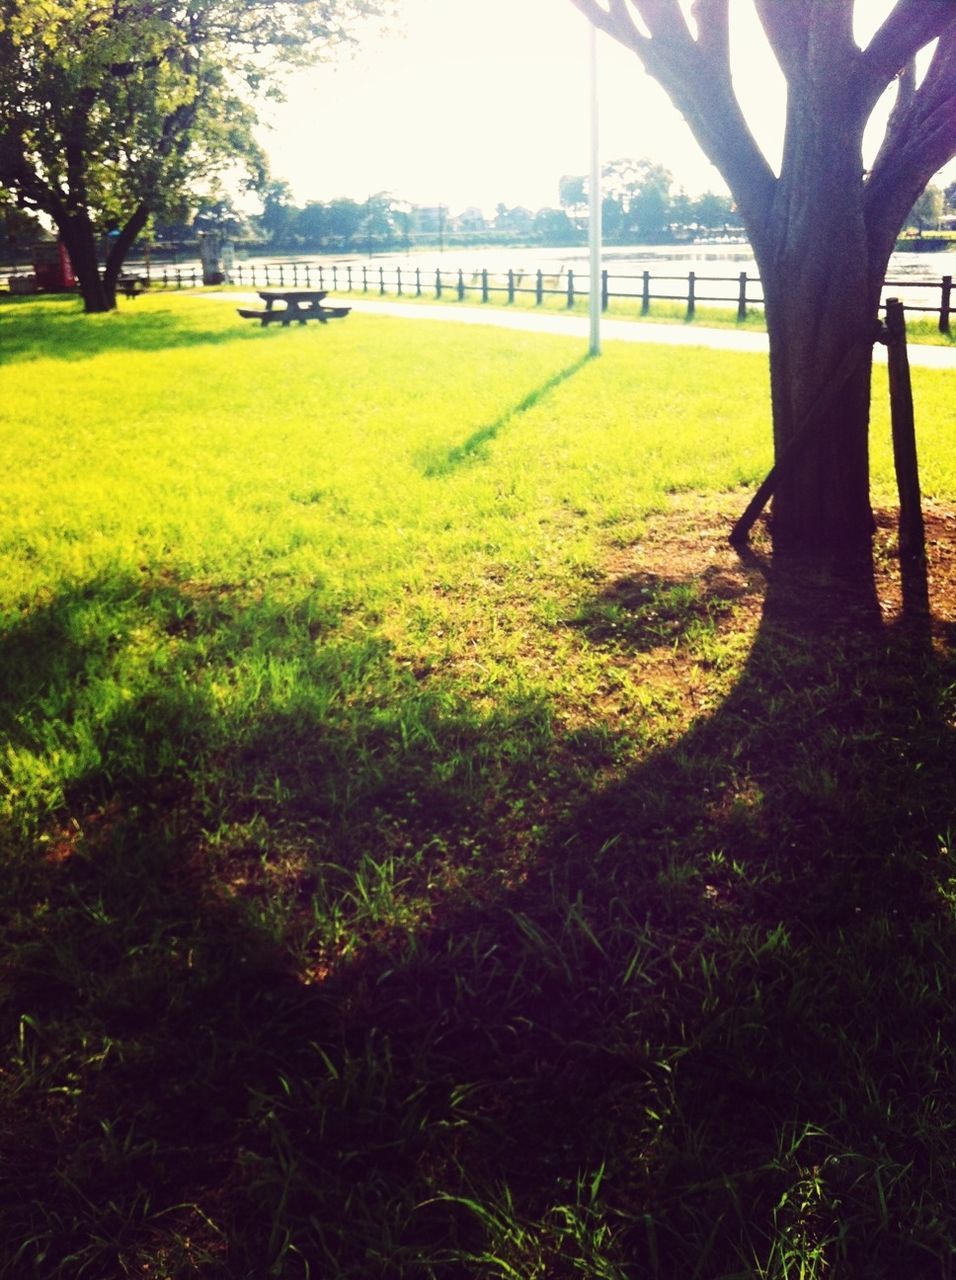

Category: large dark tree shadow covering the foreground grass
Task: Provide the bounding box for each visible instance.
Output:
[3,532,956,1280]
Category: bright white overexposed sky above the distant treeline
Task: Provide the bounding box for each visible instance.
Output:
[262,0,952,212]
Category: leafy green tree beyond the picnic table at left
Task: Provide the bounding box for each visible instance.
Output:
[0,0,379,311]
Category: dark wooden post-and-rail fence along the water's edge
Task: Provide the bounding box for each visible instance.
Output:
[145,261,952,333]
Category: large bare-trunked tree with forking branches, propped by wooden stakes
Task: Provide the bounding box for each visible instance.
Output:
[572,0,956,556]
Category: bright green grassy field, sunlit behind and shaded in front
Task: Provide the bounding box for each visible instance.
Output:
[0,296,956,1280]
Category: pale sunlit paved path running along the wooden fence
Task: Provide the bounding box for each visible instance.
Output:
[220,293,956,369]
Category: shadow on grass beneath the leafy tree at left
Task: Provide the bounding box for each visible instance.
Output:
[0,300,259,367]
